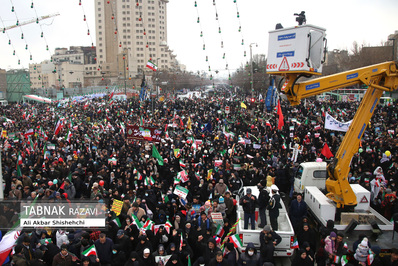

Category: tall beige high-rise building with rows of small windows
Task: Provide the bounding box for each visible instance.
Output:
[95,0,178,79]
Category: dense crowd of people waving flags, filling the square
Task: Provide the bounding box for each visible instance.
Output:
[0,92,398,266]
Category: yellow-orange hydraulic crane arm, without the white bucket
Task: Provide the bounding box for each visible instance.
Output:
[281,62,398,207]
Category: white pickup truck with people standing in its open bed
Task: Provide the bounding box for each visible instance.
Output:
[236,186,294,257]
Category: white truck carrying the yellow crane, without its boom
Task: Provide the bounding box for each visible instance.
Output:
[294,162,398,253]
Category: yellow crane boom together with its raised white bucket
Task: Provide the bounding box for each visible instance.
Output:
[267,25,398,208]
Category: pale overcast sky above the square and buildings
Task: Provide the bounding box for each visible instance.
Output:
[0,0,398,78]
